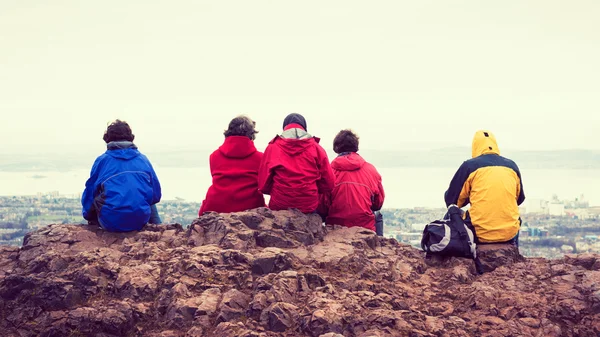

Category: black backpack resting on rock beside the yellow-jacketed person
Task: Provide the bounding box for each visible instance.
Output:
[421,205,483,274]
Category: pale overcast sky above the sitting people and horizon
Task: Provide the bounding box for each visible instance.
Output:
[0,0,600,156]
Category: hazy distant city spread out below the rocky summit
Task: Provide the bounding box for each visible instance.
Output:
[0,192,600,258]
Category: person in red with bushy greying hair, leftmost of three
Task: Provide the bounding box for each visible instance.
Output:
[198,116,265,216]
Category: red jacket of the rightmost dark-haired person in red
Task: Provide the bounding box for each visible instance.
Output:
[319,152,385,231]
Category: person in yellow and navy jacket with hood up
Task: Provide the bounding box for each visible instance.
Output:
[444,130,525,246]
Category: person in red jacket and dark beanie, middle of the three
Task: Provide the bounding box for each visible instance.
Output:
[258,113,334,213]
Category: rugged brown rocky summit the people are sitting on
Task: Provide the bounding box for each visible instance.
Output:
[0,208,600,337]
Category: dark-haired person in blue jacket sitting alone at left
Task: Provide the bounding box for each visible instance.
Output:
[81,119,161,232]
